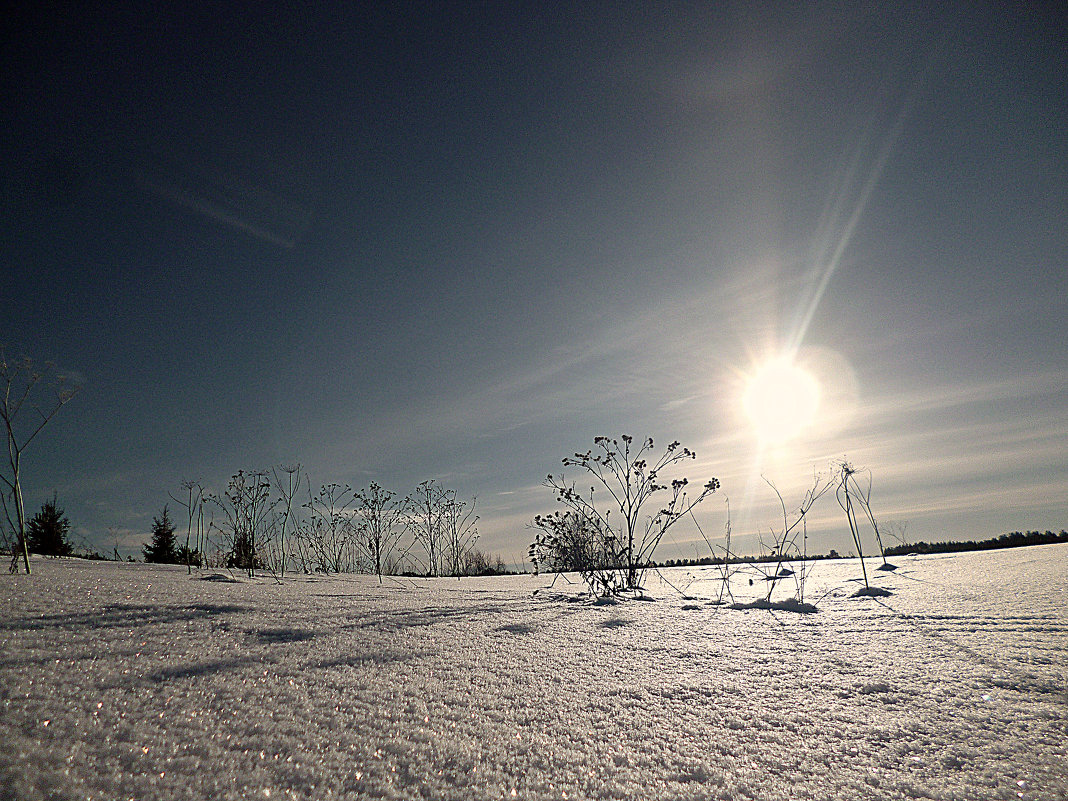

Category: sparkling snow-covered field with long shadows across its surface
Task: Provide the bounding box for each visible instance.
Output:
[0,545,1068,801]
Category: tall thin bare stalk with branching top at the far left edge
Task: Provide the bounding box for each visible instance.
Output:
[0,346,79,572]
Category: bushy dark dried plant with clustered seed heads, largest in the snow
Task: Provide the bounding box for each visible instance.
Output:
[530,435,720,595]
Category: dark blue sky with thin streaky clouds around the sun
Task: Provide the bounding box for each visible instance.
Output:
[0,3,1068,561]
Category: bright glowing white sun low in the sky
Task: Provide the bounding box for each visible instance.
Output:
[741,357,819,444]
